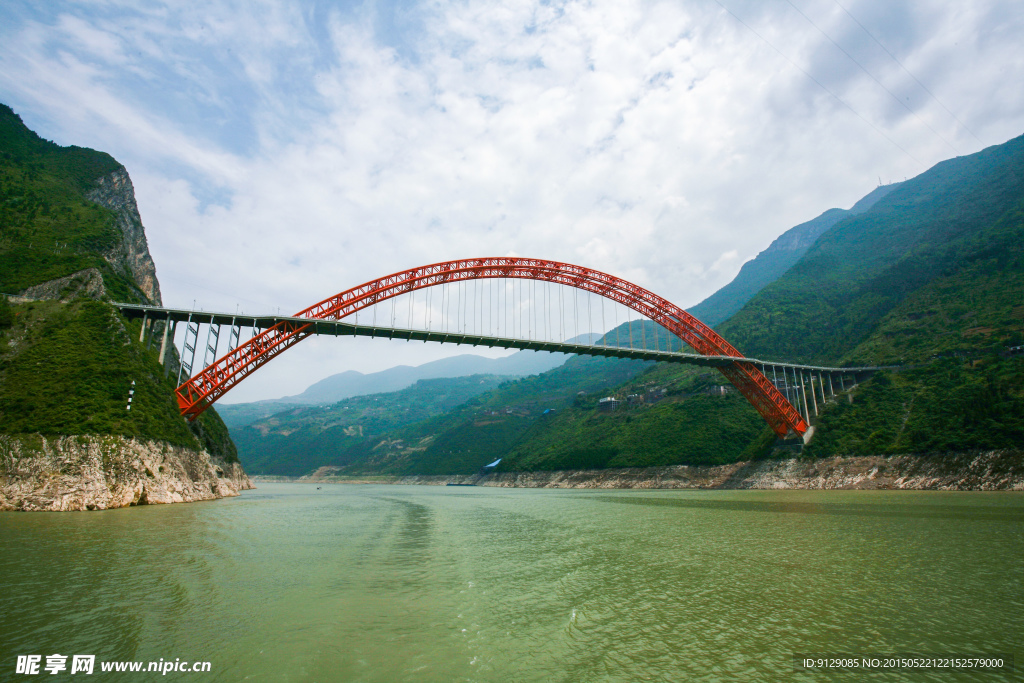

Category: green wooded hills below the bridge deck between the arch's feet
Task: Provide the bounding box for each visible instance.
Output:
[236,357,764,476]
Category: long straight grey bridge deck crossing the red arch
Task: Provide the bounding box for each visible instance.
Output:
[114,303,892,376]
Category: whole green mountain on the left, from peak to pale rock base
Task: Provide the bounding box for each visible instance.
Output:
[0,104,237,462]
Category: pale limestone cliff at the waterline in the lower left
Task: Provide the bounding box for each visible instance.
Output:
[0,435,254,511]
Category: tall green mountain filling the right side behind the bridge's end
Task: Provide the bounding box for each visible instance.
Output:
[722,137,1024,456]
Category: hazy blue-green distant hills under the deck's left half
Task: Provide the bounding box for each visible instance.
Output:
[231,356,651,476]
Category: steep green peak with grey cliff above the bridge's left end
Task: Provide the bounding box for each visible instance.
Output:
[0,104,160,303]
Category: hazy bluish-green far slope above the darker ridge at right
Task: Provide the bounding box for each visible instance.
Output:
[721,137,1024,362]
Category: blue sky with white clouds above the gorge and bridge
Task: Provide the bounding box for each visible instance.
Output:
[0,0,1024,402]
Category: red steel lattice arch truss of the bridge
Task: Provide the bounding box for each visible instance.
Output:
[175,257,807,435]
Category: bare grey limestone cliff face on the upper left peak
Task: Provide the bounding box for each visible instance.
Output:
[87,168,163,306]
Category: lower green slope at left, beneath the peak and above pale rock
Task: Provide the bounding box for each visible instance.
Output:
[0,300,237,460]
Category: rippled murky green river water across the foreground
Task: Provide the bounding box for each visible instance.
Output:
[0,483,1024,681]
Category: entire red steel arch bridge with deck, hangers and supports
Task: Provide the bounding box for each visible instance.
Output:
[116,257,879,436]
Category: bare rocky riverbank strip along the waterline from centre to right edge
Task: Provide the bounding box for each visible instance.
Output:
[262,451,1024,490]
